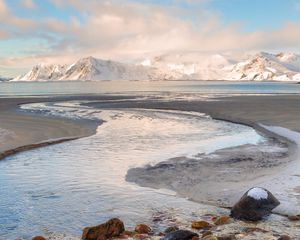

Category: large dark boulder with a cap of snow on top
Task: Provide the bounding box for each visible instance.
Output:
[230,188,280,221]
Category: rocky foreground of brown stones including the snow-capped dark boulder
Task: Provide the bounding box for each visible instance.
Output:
[32,188,300,240]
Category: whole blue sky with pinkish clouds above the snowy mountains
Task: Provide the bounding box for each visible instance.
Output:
[0,0,300,76]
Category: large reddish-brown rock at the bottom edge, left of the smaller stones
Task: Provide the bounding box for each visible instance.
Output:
[82,218,125,240]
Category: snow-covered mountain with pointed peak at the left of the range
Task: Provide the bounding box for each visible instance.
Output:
[13,57,174,81]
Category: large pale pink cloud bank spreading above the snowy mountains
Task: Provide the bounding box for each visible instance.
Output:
[0,0,300,76]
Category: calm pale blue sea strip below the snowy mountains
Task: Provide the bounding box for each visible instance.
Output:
[0,81,300,96]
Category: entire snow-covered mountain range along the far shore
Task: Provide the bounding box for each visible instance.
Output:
[12,52,300,81]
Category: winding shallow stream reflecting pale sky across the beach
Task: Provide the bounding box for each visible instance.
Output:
[0,103,264,239]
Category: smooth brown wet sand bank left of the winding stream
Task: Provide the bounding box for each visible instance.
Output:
[0,98,98,160]
